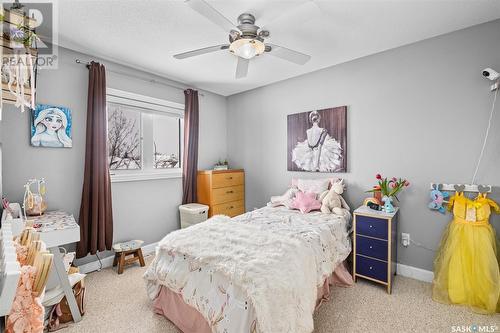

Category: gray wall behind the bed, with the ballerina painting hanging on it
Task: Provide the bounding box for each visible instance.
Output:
[227,20,500,270]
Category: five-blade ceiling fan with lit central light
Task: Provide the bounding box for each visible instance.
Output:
[174,0,311,79]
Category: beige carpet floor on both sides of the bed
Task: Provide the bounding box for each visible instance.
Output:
[60,258,500,333]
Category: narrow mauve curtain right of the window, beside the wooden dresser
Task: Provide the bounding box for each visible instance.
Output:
[182,89,199,204]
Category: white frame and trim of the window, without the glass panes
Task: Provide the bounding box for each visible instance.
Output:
[106,88,184,183]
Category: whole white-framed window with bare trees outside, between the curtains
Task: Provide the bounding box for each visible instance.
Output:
[107,88,184,181]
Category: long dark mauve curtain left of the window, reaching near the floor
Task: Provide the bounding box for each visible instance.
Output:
[76,62,113,258]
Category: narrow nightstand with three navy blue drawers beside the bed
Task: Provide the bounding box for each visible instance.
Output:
[353,206,398,294]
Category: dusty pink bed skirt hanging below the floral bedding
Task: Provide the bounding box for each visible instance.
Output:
[153,262,354,333]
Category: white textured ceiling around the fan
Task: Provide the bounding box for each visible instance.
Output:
[59,0,500,96]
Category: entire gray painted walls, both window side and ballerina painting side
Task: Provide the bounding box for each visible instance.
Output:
[0,20,500,269]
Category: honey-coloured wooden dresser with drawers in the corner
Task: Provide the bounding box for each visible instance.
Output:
[198,170,245,217]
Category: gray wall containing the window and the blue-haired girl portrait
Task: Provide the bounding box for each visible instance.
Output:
[1,49,226,262]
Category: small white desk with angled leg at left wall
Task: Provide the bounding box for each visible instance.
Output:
[2,203,82,323]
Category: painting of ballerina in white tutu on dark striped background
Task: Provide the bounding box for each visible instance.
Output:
[288,106,347,172]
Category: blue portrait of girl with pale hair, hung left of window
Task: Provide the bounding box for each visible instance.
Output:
[31,104,73,148]
